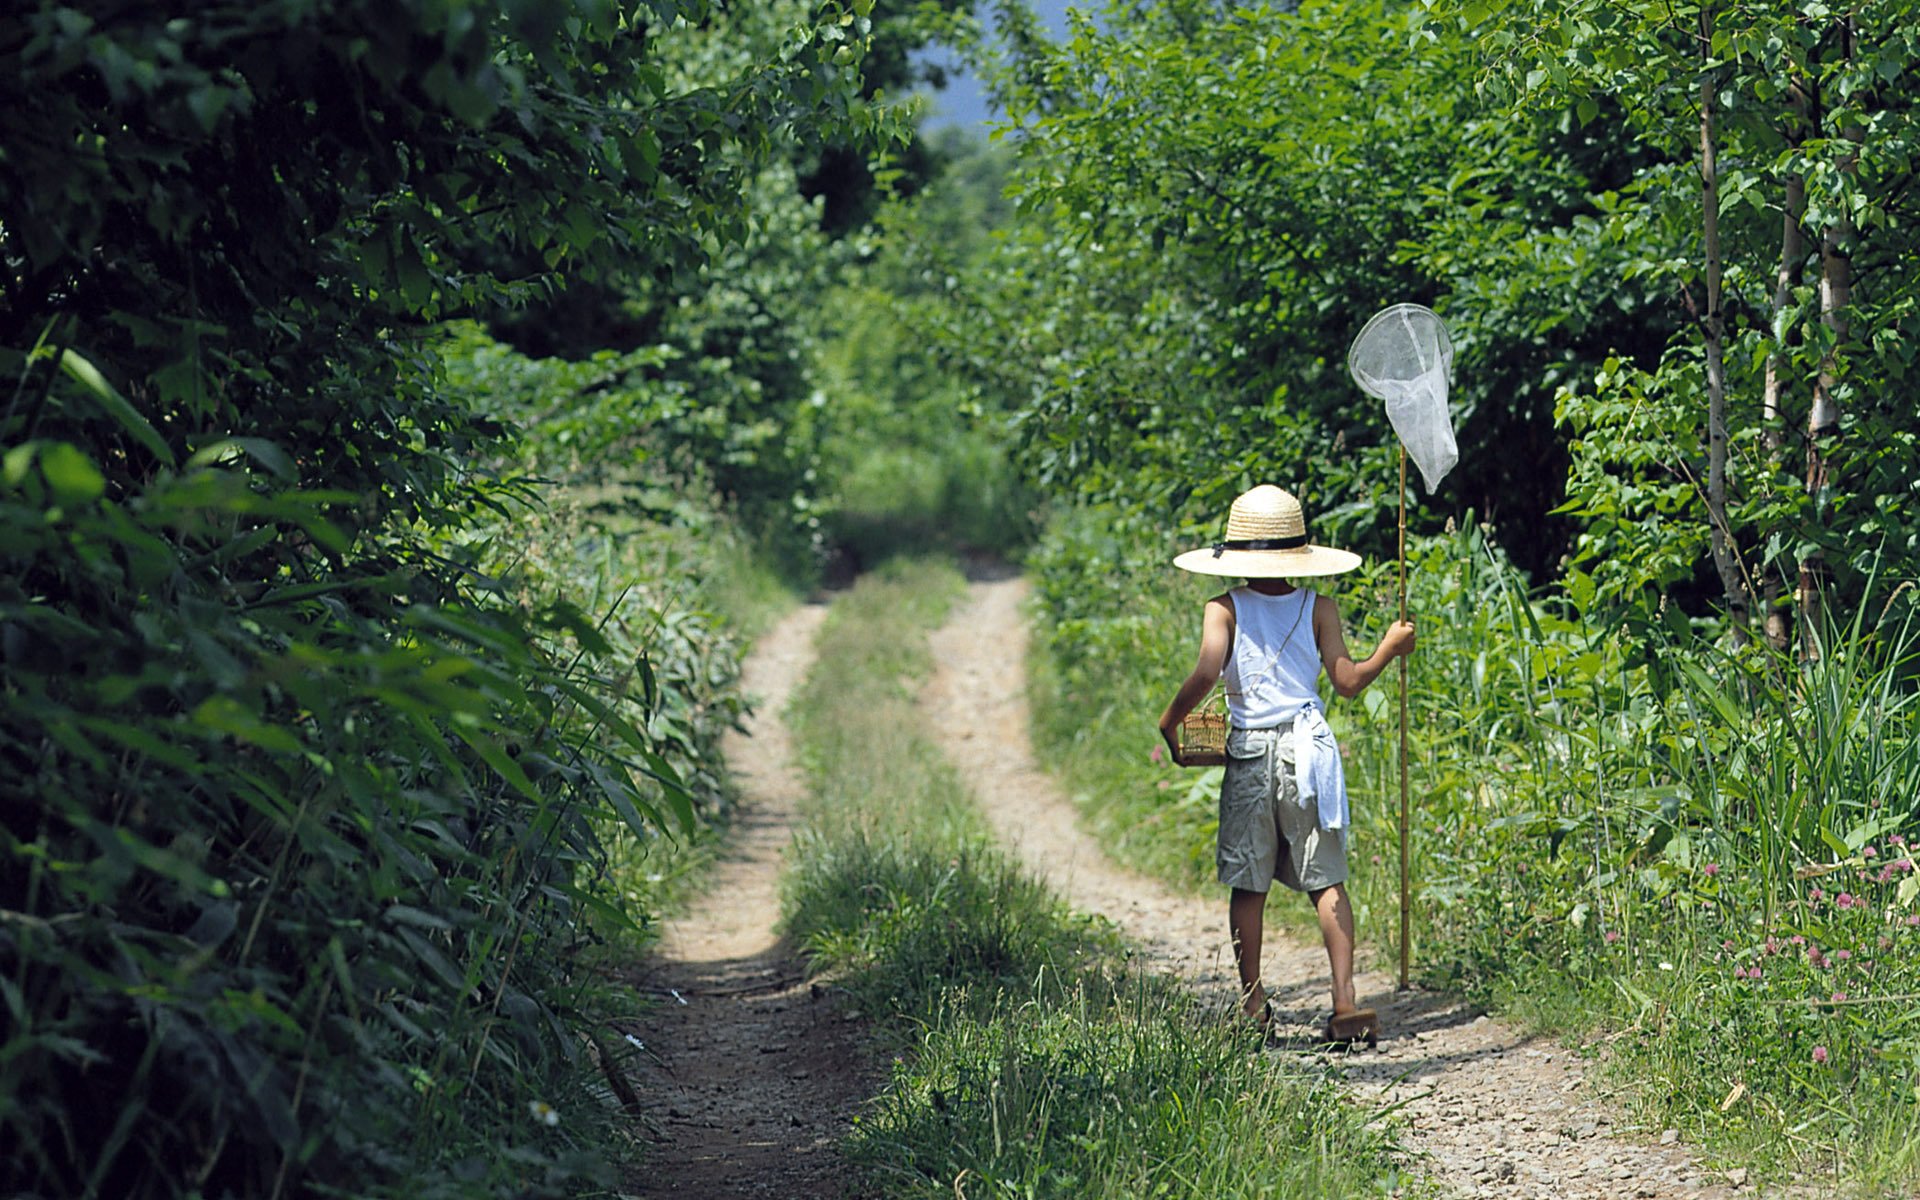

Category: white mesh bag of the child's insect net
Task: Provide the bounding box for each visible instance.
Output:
[1346,303,1459,492]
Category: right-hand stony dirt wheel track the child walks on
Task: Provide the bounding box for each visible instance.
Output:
[922,578,1734,1200]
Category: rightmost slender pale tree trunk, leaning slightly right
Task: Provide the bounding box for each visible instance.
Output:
[1799,17,1860,659]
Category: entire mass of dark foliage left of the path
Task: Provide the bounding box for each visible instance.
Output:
[0,0,885,1194]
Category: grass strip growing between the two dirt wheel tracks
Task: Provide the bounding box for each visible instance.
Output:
[787,561,1421,1198]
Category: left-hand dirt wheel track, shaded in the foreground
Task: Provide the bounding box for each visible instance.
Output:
[628,605,876,1198]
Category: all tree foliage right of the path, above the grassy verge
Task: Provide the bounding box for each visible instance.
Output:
[967,2,1920,643]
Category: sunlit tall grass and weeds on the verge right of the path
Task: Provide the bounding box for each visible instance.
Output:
[1029,515,1920,1194]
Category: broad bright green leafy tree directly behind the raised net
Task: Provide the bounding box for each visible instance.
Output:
[970,4,1663,568]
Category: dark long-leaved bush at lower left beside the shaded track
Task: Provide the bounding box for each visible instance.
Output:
[0,444,706,1196]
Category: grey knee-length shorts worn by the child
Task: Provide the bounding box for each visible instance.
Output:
[1215,724,1346,891]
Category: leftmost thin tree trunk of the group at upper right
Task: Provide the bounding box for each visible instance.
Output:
[1699,4,1751,643]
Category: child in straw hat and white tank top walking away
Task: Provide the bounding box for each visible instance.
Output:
[1160,484,1413,1043]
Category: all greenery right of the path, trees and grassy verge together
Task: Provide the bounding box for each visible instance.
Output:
[939,0,1920,1190]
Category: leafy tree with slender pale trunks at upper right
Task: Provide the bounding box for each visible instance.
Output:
[1453,2,1920,643]
